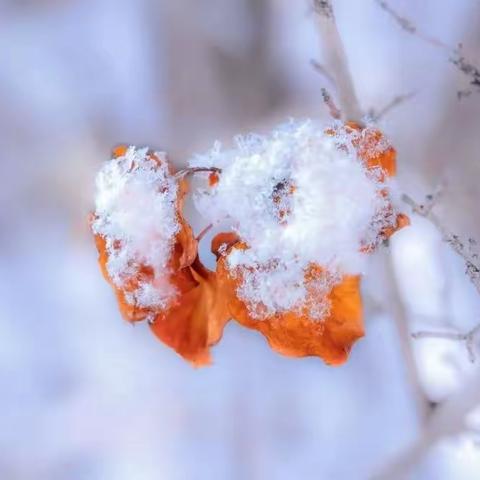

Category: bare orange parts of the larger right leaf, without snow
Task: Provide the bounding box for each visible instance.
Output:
[212,123,402,365]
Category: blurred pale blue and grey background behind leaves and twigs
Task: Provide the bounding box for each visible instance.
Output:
[0,0,480,480]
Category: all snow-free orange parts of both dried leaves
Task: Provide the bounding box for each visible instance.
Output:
[95,122,409,366]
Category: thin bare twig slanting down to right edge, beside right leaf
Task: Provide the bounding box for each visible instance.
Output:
[402,194,480,293]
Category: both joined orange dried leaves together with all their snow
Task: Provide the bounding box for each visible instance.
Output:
[91,121,408,366]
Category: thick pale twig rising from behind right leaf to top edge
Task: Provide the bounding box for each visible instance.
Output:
[313,0,363,124]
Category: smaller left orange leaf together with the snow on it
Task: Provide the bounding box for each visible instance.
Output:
[91,146,234,366]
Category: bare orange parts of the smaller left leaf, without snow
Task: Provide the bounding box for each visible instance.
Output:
[90,146,229,366]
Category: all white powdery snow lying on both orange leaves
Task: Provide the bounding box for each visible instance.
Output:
[93,121,395,319]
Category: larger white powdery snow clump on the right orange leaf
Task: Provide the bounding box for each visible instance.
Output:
[190,120,394,319]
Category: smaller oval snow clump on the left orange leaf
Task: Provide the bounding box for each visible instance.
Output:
[92,147,179,307]
